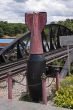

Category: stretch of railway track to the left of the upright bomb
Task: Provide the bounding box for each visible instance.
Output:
[0,58,27,81]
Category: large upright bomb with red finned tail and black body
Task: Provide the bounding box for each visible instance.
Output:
[25,12,47,102]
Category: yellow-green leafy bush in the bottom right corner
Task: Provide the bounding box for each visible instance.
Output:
[54,75,73,109]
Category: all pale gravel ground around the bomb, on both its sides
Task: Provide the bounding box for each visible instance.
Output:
[0,73,55,105]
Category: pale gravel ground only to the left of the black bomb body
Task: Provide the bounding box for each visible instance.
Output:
[0,74,26,100]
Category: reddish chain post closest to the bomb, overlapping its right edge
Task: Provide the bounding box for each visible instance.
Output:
[41,73,47,104]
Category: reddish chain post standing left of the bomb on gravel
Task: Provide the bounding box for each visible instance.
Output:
[7,72,12,99]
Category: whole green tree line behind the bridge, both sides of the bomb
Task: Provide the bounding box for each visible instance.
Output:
[0,19,73,36]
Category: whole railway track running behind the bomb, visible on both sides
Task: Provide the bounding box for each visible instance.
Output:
[0,47,73,81]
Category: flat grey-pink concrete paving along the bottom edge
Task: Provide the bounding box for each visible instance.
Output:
[0,99,71,110]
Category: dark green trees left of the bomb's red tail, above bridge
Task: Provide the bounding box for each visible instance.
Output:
[0,21,27,36]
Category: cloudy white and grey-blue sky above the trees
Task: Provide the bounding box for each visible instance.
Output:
[0,0,73,23]
